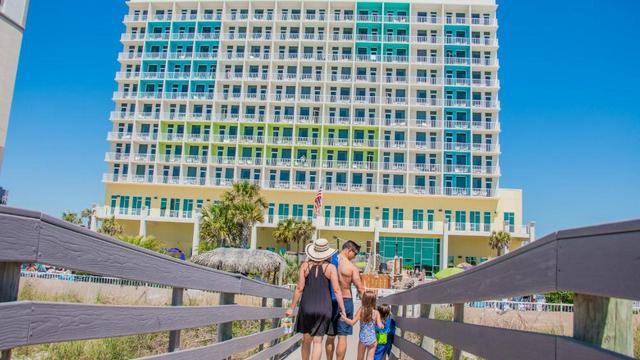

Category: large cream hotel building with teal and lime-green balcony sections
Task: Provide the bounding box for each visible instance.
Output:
[98,0,535,271]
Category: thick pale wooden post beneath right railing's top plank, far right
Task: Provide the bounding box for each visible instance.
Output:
[573,294,633,357]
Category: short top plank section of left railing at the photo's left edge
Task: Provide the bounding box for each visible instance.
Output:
[0,212,40,262]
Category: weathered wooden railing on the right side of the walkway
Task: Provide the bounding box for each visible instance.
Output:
[380,220,640,360]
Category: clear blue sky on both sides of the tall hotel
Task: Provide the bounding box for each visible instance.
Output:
[0,0,640,237]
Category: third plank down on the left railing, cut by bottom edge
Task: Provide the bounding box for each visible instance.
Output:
[141,328,284,360]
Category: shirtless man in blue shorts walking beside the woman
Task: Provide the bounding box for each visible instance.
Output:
[325,240,364,360]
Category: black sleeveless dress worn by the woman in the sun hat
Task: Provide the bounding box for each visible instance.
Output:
[296,264,333,336]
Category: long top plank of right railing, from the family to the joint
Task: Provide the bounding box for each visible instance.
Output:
[381,235,557,305]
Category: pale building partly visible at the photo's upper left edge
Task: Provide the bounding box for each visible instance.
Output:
[0,0,28,170]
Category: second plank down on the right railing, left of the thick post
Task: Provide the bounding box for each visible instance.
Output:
[396,318,556,360]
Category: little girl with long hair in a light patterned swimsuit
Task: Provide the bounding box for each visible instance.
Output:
[342,290,384,360]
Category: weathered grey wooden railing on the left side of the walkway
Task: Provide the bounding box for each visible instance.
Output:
[0,207,300,360]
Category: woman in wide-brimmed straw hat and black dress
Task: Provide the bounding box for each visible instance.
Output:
[286,239,345,360]
